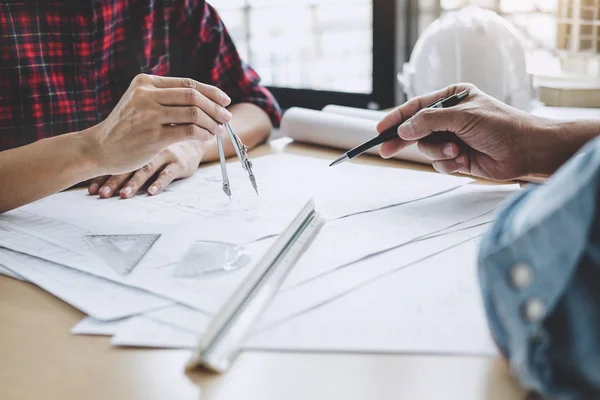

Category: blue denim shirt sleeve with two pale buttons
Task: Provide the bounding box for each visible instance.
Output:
[479,138,600,399]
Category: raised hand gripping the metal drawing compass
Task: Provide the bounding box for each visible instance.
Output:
[87,74,231,175]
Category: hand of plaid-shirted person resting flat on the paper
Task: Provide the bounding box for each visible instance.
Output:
[88,140,204,199]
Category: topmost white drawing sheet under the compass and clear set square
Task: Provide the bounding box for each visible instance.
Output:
[0,155,470,313]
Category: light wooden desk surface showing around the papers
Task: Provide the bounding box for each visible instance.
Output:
[0,140,525,400]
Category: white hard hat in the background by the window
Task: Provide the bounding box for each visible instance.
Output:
[398,6,534,110]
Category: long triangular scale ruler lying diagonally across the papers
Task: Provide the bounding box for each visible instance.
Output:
[186,200,325,372]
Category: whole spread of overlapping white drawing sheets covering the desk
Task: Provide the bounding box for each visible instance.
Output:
[0,155,517,353]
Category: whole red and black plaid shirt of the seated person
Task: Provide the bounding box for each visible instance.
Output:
[0,0,281,151]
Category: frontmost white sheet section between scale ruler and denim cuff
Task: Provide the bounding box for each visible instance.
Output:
[246,240,498,356]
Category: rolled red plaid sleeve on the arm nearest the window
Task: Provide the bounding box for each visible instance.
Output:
[170,0,281,126]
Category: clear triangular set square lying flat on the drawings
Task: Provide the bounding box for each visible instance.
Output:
[83,234,160,275]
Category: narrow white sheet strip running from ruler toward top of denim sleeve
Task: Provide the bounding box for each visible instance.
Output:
[283,185,520,289]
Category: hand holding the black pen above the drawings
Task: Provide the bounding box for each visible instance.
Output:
[377,84,557,180]
